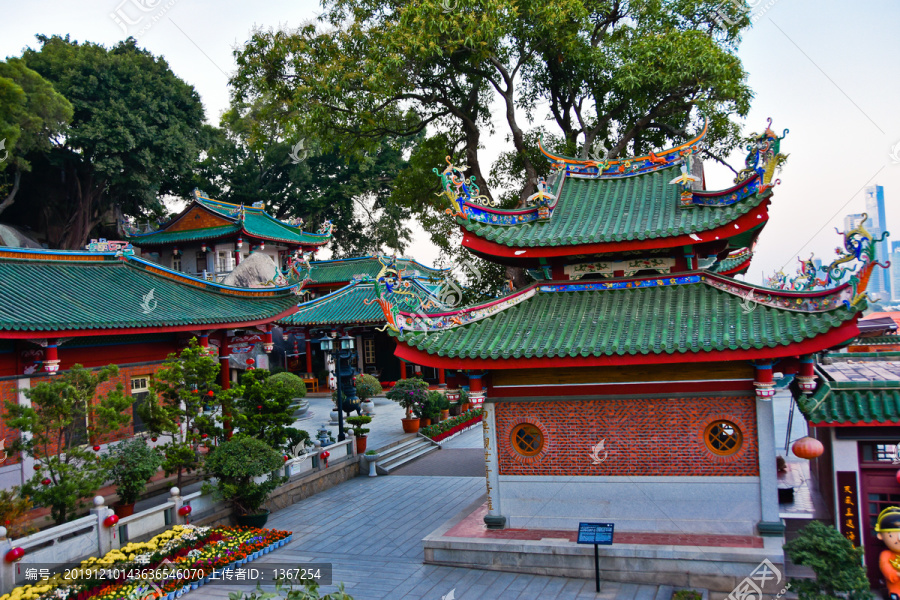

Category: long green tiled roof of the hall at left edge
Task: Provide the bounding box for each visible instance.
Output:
[0,249,300,339]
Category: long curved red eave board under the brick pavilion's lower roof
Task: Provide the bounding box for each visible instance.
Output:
[394,313,859,369]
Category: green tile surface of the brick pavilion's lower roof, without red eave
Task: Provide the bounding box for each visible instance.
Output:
[395,272,864,359]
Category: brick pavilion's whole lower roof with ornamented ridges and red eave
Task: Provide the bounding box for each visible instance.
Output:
[389,271,861,368]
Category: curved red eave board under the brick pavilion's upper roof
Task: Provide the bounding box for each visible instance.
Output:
[460,198,771,259]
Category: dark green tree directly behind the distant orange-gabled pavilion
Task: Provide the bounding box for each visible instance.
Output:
[195,103,413,256]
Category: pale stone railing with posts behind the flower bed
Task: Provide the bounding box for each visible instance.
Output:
[0,436,357,594]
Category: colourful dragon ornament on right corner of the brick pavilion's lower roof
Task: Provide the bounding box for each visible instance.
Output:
[766,213,891,305]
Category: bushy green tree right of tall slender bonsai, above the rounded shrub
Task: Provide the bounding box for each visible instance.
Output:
[234,369,298,450]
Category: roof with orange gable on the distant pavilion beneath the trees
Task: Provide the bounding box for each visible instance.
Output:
[121,189,333,247]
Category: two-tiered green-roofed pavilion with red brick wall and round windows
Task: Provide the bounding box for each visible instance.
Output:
[385,122,874,593]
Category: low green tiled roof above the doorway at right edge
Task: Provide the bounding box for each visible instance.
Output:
[797,381,900,425]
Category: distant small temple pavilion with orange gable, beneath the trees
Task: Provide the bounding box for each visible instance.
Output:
[121,190,332,282]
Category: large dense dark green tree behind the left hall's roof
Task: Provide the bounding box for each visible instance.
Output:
[16,36,203,248]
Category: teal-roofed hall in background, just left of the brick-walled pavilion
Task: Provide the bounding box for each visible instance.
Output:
[280,256,449,386]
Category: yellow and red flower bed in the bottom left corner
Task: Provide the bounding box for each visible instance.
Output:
[0,525,291,600]
